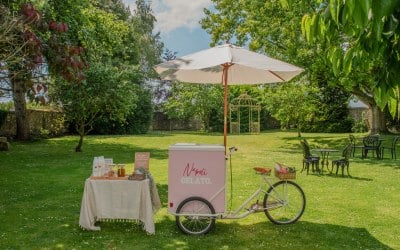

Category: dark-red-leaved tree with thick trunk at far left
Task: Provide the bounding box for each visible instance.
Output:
[0,1,86,140]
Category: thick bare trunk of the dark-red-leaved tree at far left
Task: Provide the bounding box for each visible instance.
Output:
[12,78,30,140]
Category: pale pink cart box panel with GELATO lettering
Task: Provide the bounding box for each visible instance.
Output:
[168,143,226,213]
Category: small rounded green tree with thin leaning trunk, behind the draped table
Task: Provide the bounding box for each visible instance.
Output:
[55,63,137,152]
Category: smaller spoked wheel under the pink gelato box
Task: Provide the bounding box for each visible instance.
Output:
[175,197,215,235]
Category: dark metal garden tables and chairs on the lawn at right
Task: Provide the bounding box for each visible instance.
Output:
[300,135,400,176]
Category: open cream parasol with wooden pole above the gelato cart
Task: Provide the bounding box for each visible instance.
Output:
[155,44,303,150]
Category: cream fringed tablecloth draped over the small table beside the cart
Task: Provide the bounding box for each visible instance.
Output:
[79,178,161,234]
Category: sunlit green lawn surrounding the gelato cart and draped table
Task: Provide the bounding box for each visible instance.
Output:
[0,131,400,249]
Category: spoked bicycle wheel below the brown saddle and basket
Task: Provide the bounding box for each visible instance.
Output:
[263,181,306,224]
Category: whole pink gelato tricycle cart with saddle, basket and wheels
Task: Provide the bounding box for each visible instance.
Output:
[168,143,306,235]
